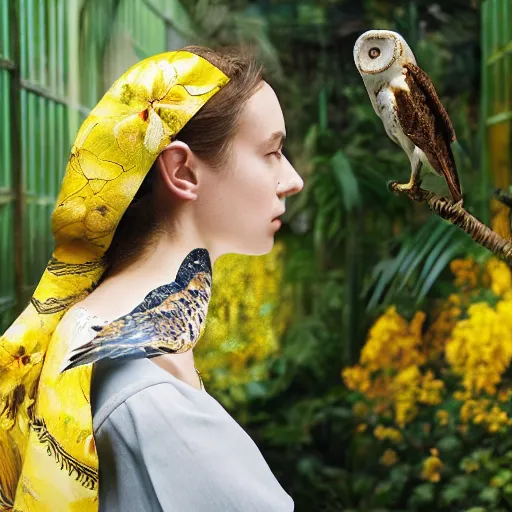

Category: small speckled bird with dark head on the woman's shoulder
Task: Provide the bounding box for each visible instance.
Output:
[61,249,212,373]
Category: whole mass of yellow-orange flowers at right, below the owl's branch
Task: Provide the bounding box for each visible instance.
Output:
[342,254,512,433]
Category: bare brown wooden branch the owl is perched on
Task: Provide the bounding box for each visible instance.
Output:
[390,182,512,266]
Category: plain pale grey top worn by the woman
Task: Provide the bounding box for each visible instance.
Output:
[91,359,294,512]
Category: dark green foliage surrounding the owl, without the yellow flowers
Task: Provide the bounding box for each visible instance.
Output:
[212,0,488,512]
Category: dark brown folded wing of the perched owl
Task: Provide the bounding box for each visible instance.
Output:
[394,64,462,202]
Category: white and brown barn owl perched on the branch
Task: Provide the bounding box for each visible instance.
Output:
[354,30,462,204]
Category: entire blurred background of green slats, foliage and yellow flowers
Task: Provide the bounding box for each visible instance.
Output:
[0,0,512,512]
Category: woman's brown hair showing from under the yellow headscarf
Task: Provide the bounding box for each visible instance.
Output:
[104,46,263,277]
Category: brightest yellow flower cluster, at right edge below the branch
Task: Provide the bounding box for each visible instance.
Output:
[445,300,512,395]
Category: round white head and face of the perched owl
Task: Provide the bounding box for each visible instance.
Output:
[354,30,414,75]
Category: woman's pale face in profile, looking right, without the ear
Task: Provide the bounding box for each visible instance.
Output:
[195,82,304,255]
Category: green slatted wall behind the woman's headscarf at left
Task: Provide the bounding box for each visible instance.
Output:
[0,0,187,332]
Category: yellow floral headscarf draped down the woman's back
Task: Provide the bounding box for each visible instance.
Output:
[0,51,229,512]
